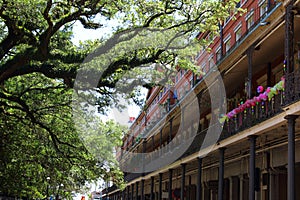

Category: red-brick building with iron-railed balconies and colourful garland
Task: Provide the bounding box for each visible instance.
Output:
[104,0,300,200]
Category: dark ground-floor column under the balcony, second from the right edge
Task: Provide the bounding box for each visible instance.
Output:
[249,135,257,200]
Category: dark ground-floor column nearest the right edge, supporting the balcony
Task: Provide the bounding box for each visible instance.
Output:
[285,115,298,200]
